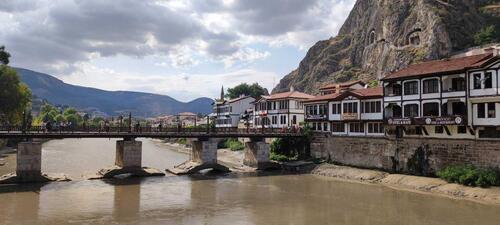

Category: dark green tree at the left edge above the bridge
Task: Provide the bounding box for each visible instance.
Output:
[0,65,31,124]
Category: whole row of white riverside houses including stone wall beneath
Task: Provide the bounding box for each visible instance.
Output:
[210,53,500,175]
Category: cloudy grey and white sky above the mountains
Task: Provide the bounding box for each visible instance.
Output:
[0,0,355,101]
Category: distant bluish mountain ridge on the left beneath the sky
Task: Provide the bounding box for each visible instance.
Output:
[15,68,213,117]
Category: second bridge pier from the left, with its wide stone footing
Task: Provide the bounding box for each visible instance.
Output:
[91,139,165,179]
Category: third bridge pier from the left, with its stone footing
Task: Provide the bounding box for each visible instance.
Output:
[167,138,229,175]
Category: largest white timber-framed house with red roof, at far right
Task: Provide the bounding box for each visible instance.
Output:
[382,53,500,139]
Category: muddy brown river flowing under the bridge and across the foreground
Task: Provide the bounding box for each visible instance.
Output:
[0,139,500,225]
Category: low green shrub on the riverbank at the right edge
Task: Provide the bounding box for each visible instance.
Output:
[437,165,500,187]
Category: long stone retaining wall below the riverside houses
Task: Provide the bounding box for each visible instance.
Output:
[311,135,500,175]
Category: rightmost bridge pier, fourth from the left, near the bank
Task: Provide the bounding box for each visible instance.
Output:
[243,138,277,170]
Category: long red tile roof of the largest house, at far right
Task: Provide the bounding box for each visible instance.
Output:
[382,53,493,80]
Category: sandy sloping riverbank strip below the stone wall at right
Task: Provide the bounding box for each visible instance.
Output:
[311,163,500,205]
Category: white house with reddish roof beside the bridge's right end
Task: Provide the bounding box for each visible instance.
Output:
[253,87,314,128]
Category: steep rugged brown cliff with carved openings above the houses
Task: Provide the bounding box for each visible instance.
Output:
[273,0,500,94]
